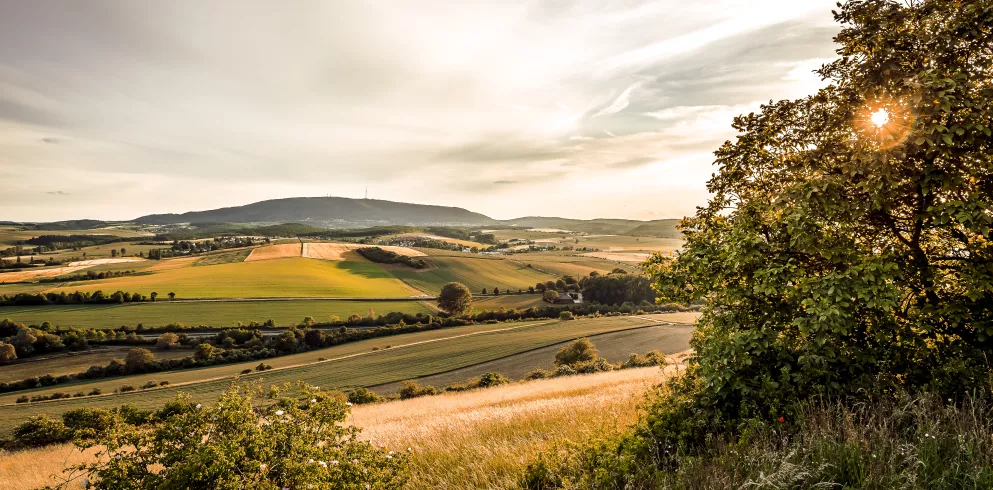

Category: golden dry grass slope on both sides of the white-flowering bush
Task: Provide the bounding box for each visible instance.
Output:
[0,368,671,490]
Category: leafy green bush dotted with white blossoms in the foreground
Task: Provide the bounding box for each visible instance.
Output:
[49,386,407,490]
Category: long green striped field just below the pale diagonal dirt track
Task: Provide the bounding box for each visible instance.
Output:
[0,314,678,431]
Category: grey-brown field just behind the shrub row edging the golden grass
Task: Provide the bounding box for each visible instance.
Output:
[372,324,694,394]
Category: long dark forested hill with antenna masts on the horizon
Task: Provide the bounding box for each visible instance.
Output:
[135,197,495,226]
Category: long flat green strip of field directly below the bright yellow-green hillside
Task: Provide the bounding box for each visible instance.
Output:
[0,300,437,328]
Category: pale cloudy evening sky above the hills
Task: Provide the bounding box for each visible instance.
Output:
[0,0,838,221]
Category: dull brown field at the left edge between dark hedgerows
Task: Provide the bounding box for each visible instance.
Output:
[0,347,193,382]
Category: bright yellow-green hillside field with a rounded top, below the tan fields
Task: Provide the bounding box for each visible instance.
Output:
[42,257,419,299]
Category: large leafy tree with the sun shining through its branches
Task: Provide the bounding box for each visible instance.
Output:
[649,0,993,417]
